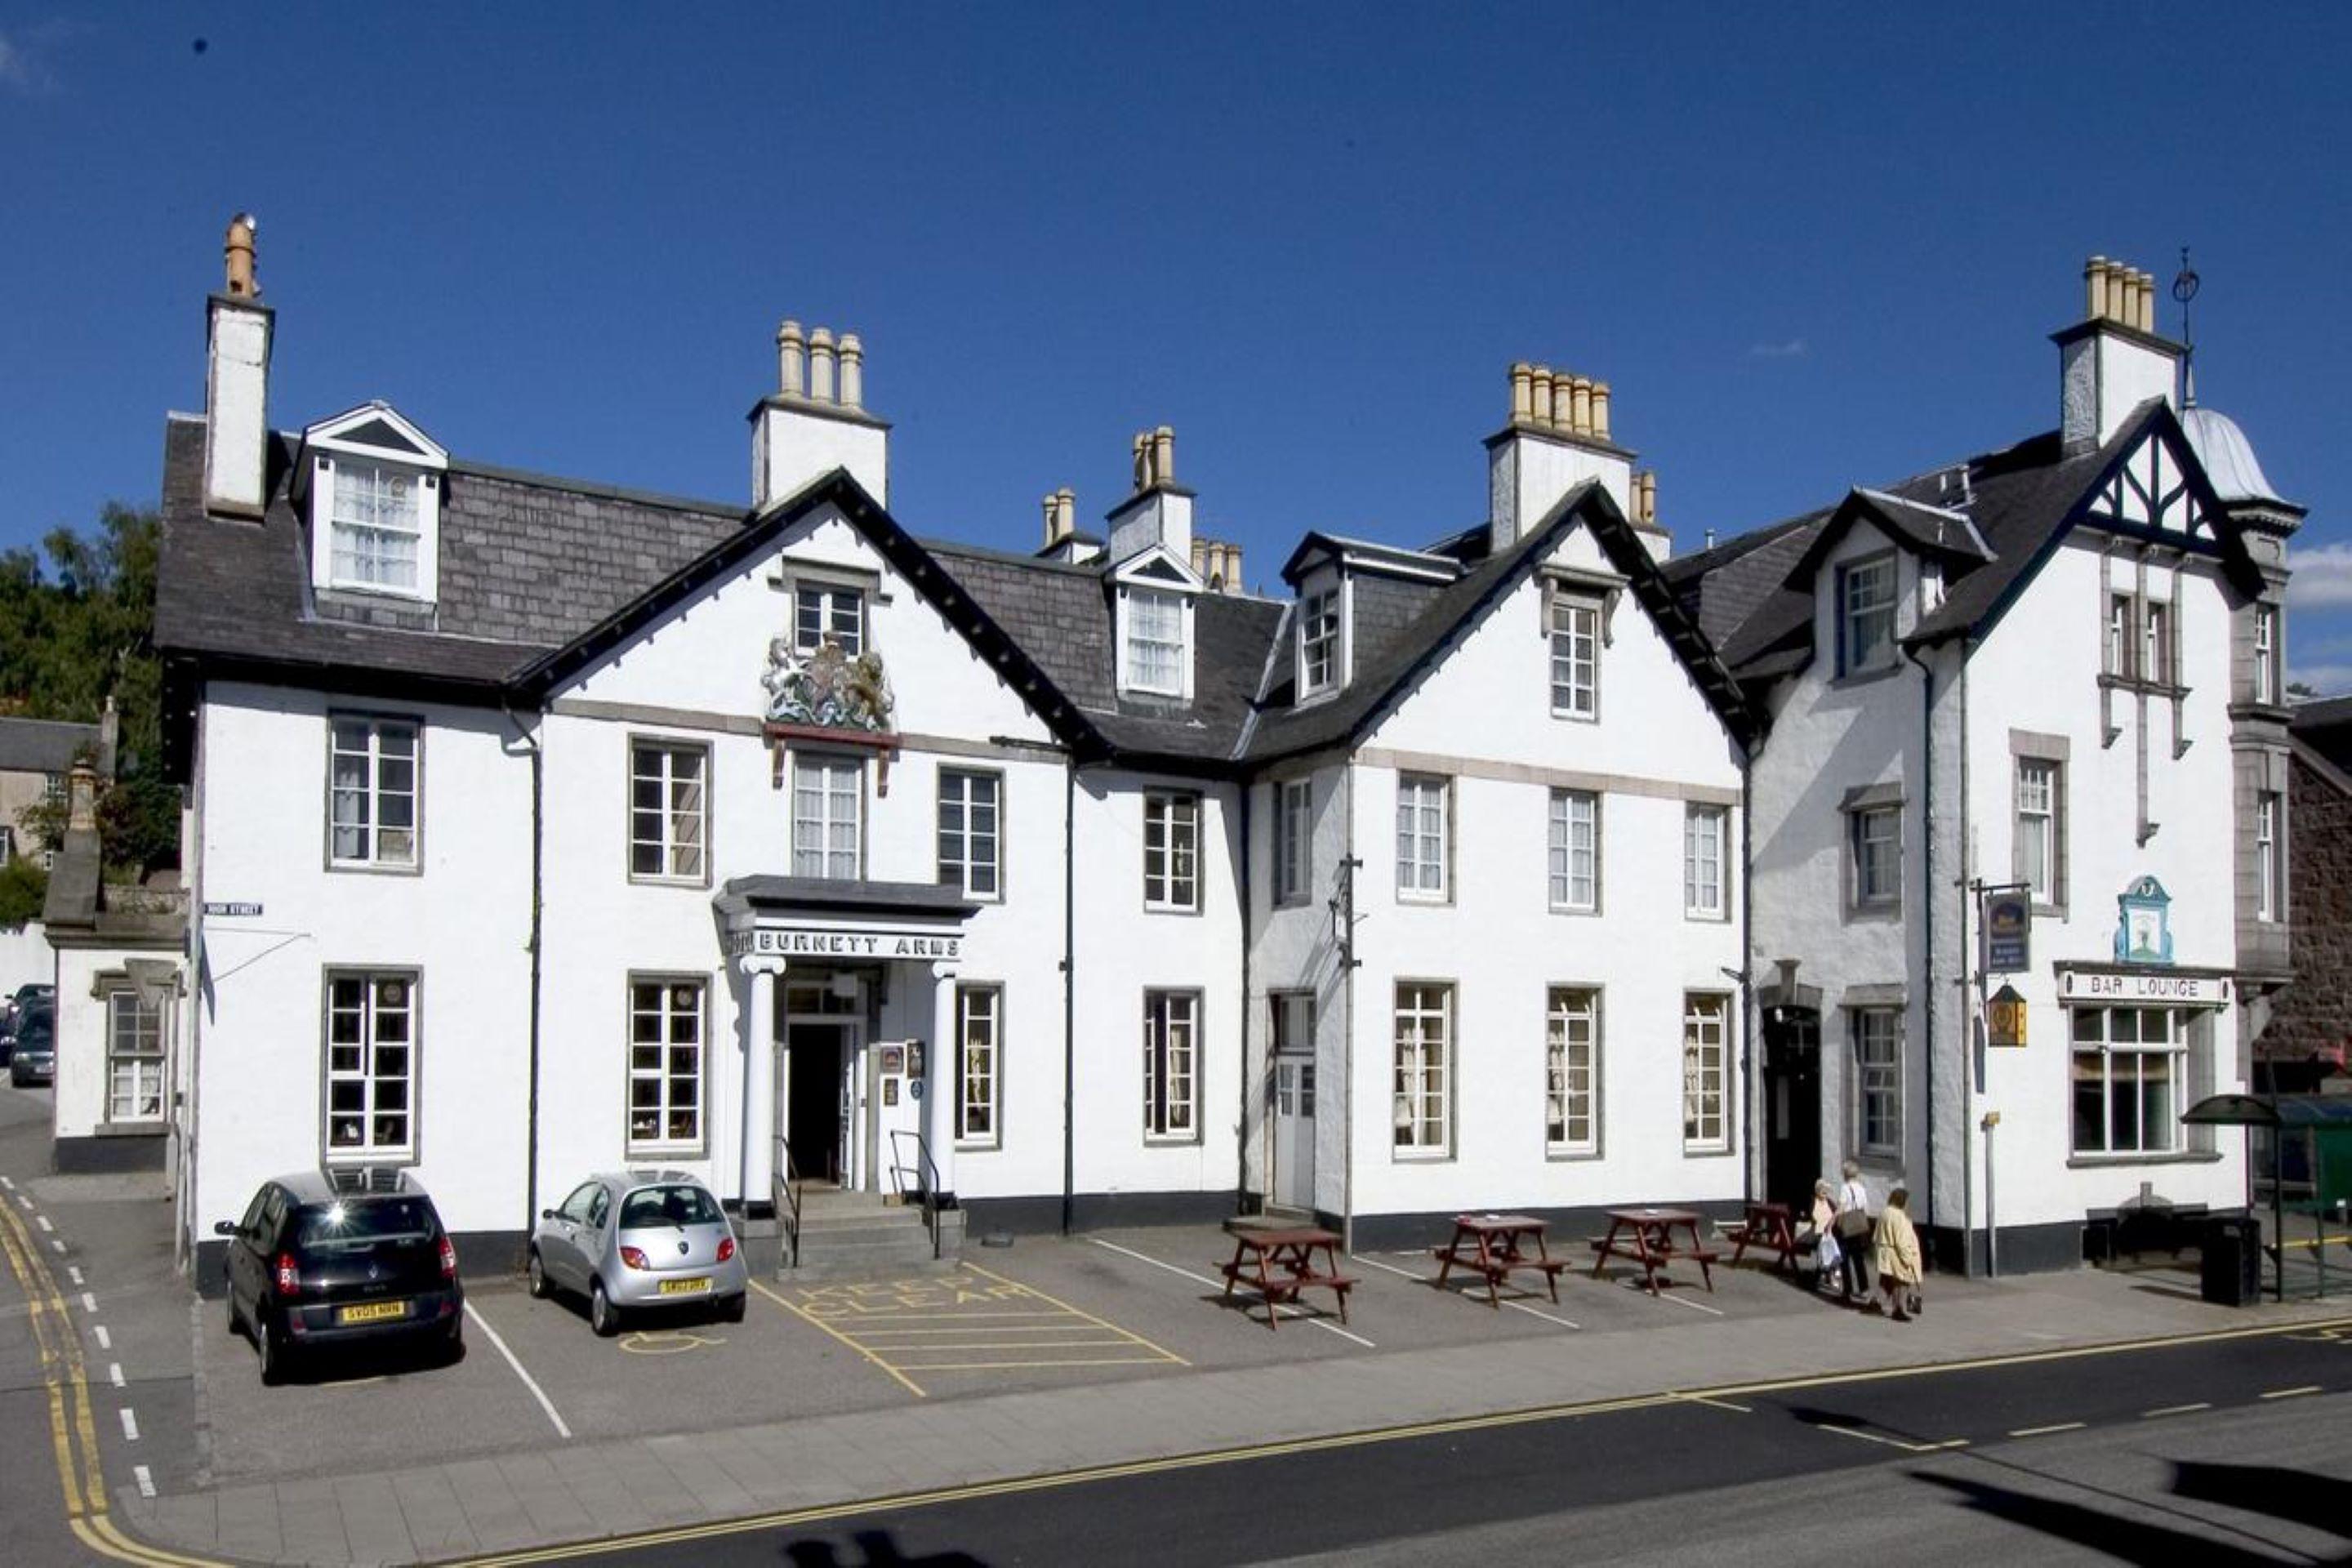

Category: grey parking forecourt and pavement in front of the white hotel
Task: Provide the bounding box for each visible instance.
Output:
[0,1105,2347,1563]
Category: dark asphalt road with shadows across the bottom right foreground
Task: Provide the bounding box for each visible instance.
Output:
[541,1330,2352,1568]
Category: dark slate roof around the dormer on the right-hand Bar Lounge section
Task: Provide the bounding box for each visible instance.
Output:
[1665,399,2178,687]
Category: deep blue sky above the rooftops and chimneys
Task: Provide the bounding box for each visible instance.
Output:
[13,2,2352,691]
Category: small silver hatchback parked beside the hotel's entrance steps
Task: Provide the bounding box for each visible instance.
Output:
[529,1171,751,1335]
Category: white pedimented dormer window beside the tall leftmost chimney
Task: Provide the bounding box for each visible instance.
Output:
[294,402,449,602]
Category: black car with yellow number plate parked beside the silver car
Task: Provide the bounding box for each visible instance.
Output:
[212,1169,466,1383]
